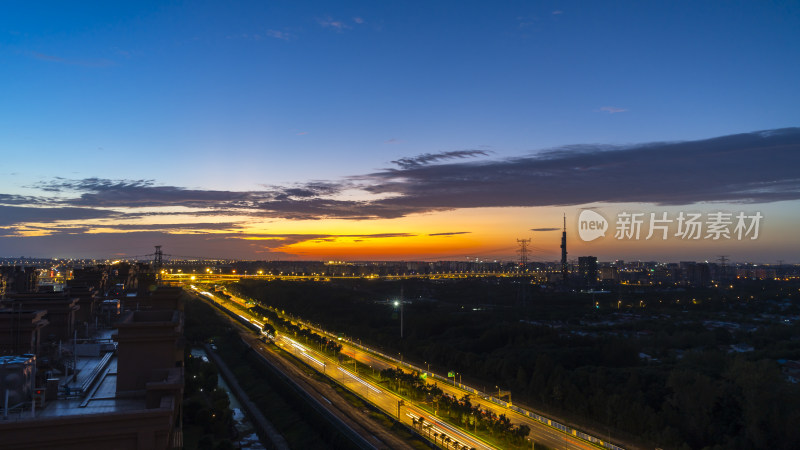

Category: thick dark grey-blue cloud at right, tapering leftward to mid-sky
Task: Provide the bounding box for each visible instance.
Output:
[364,128,800,212]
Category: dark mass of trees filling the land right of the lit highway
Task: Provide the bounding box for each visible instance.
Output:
[231,280,800,449]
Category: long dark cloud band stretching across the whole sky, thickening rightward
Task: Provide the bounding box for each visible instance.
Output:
[10,128,800,225]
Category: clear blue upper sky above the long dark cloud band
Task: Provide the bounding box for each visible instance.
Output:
[0,1,800,257]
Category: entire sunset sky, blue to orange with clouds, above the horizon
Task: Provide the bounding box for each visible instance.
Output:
[0,1,800,264]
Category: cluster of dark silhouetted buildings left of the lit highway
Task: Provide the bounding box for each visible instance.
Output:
[0,267,184,450]
